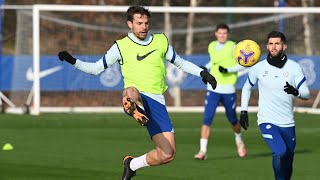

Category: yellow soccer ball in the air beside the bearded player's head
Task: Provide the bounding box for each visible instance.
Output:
[233,39,261,67]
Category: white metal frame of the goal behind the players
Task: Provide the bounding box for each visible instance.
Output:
[2,4,320,115]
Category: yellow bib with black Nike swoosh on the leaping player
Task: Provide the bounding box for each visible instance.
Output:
[116,34,168,94]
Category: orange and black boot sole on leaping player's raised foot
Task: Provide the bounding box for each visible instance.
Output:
[122,96,149,126]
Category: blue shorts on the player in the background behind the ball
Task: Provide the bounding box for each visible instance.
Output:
[203,91,238,126]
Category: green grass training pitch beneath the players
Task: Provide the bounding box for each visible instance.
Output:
[0,113,320,180]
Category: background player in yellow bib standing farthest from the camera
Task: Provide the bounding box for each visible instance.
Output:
[194,24,247,160]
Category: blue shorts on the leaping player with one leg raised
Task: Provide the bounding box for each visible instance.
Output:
[140,93,174,138]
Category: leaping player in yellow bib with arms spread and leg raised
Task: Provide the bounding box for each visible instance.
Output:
[59,6,217,180]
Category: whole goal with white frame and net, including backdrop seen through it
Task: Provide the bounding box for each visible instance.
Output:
[0,5,320,114]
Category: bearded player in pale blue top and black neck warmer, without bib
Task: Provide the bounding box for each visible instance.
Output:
[240,31,310,180]
